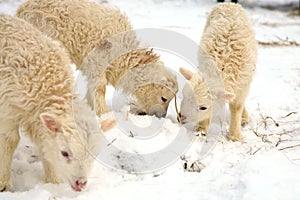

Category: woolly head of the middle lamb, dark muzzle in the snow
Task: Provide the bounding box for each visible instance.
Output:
[126,63,178,117]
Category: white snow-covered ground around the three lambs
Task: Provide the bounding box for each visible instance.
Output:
[0,0,300,200]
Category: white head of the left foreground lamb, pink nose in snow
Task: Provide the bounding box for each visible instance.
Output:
[40,103,101,191]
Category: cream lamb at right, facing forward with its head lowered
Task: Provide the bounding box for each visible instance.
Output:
[180,3,257,141]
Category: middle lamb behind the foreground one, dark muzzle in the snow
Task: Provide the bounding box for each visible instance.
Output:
[17,0,178,117]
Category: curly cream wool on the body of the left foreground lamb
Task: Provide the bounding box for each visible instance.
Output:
[0,15,74,128]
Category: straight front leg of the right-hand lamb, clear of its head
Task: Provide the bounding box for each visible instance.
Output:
[228,100,244,141]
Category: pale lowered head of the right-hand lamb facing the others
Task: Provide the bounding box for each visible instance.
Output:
[179,68,212,126]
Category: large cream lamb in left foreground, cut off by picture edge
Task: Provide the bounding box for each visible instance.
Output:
[0,14,105,192]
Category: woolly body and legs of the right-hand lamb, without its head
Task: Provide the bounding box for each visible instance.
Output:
[199,3,257,141]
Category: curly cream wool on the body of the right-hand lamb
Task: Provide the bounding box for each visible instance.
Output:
[199,3,257,95]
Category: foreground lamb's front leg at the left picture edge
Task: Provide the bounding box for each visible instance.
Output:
[0,121,20,192]
